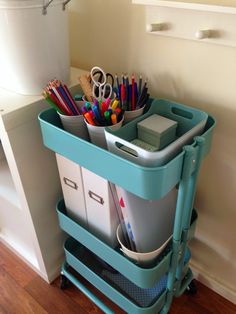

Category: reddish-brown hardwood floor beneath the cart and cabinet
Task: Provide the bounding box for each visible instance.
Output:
[0,242,236,314]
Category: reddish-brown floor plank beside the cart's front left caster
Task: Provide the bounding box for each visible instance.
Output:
[25,277,88,314]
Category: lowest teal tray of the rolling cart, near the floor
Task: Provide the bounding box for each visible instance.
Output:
[62,238,167,314]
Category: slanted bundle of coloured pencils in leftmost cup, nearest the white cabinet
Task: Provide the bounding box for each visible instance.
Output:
[43,79,80,116]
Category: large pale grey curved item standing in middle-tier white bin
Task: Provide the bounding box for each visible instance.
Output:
[116,186,178,253]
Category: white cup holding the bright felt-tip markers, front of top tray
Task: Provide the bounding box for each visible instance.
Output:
[85,117,124,149]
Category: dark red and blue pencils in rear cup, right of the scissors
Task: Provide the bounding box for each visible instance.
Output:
[115,74,150,111]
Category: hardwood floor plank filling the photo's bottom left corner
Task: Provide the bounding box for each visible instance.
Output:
[0,266,47,314]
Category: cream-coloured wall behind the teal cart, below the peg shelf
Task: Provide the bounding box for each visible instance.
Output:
[70,0,236,302]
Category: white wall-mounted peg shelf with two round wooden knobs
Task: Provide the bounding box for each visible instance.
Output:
[132,0,236,47]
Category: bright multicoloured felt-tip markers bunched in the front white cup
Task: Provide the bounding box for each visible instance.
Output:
[82,98,123,126]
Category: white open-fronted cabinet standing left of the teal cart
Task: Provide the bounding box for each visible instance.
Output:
[0,68,87,282]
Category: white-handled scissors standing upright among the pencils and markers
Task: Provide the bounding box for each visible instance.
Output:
[90,66,114,101]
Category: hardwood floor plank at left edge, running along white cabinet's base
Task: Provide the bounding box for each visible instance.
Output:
[0,242,37,287]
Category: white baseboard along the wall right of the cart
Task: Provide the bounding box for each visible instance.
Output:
[190,261,236,304]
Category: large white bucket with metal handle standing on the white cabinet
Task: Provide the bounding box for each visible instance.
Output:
[0,0,70,95]
